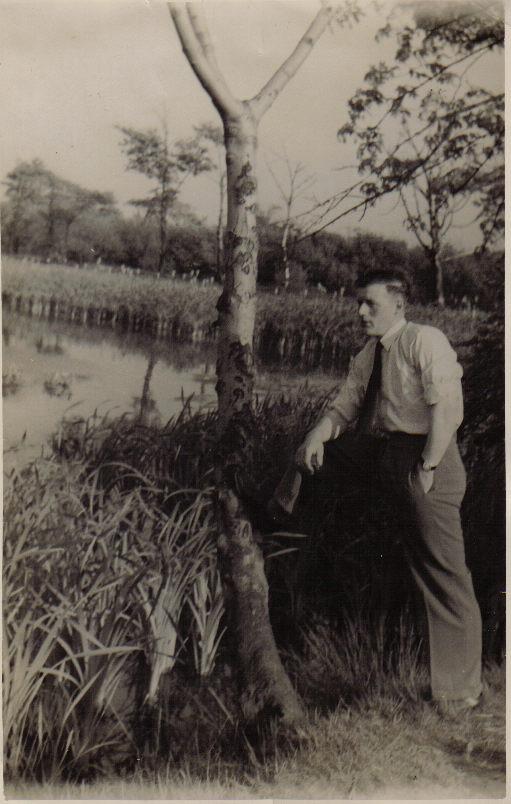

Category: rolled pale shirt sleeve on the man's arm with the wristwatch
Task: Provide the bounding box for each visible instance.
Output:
[414,326,463,406]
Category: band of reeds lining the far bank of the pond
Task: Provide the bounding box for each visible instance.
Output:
[2,257,485,371]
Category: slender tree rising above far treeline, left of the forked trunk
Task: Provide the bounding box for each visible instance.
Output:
[119,125,212,271]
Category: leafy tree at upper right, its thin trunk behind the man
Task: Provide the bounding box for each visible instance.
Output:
[339,2,504,304]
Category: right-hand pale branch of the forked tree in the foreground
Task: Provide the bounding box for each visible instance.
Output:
[249,5,333,120]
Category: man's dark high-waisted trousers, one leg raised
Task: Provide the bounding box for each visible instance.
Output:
[300,431,482,700]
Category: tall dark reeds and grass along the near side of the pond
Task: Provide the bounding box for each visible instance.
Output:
[3,288,501,780]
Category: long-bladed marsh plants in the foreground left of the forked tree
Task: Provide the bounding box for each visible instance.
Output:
[3,460,222,779]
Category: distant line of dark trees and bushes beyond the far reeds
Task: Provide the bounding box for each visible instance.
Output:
[2,160,504,310]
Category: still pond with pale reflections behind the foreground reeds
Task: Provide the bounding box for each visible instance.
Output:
[2,313,336,470]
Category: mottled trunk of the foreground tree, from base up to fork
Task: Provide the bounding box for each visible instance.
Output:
[216,105,303,722]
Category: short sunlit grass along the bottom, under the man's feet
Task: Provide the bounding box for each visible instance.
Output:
[6,652,505,800]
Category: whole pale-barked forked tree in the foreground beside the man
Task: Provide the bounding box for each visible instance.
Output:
[169,3,358,722]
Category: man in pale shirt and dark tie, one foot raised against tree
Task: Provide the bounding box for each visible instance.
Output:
[272,270,481,715]
